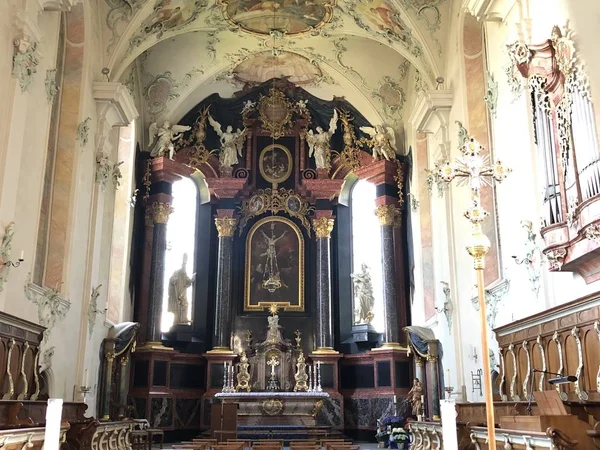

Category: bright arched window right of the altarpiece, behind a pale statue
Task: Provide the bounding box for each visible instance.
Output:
[351,180,384,331]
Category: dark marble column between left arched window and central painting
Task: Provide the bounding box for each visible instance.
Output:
[212,217,237,352]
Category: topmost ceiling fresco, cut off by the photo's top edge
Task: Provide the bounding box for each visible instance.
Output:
[221,0,335,35]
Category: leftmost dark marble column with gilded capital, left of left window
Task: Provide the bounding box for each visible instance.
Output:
[146,202,173,343]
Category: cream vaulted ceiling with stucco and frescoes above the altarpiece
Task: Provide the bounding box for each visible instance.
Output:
[100,0,452,141]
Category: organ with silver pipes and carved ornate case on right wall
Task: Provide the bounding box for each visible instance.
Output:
[507,26,600,283]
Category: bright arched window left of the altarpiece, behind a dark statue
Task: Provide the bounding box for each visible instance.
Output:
[160,178,198,332]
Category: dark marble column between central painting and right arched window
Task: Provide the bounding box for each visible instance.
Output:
[312,217,337,354]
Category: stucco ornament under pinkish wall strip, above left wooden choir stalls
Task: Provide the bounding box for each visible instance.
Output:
[24,274,71,342]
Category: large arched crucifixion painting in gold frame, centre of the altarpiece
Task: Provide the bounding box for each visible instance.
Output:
[244,216,304,311]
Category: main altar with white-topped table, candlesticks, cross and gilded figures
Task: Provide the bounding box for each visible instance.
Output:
[214,304,329,427]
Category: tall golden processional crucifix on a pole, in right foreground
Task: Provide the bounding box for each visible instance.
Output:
[438,138,511,450]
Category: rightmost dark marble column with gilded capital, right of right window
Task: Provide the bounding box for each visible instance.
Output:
[375,205,400,348]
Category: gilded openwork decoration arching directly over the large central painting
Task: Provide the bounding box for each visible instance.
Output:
[239,188,314,236]
